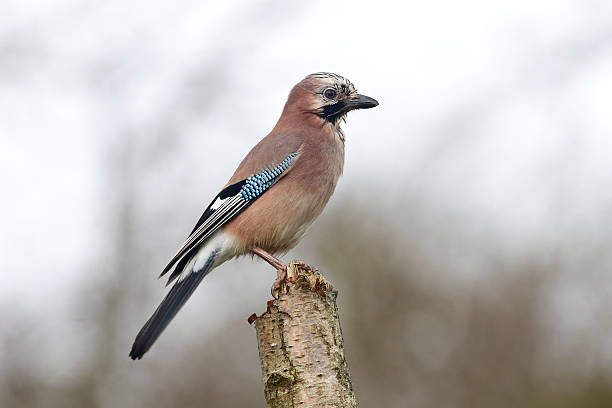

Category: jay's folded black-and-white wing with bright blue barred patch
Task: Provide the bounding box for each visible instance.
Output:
[160,151,298,283]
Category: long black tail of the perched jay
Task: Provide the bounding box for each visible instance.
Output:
[130,251,219,360]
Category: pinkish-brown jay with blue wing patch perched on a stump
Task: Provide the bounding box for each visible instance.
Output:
[129,72,378,360]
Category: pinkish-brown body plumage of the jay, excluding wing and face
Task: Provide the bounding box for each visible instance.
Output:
[224,77,344,254]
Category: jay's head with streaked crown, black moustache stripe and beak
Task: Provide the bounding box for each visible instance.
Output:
[287,72,378,127]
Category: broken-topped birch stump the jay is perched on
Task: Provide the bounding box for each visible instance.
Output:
[249,261,357,408]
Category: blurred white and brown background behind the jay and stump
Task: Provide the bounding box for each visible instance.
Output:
[0,0,612,407]
